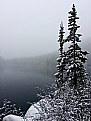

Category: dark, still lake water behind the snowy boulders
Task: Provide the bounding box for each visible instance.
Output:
[0,69,54,111]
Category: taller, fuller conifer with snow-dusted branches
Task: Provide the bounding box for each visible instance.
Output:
[67,4,88,87]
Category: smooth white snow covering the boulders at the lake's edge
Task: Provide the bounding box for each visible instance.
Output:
[3,99,52,121]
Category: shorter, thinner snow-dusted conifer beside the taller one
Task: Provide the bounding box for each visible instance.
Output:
[55,22,65,88]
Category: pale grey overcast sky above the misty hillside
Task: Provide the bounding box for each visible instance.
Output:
[0,0,91,58]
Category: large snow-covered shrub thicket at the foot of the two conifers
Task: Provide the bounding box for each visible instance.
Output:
[30,80,91,121]
